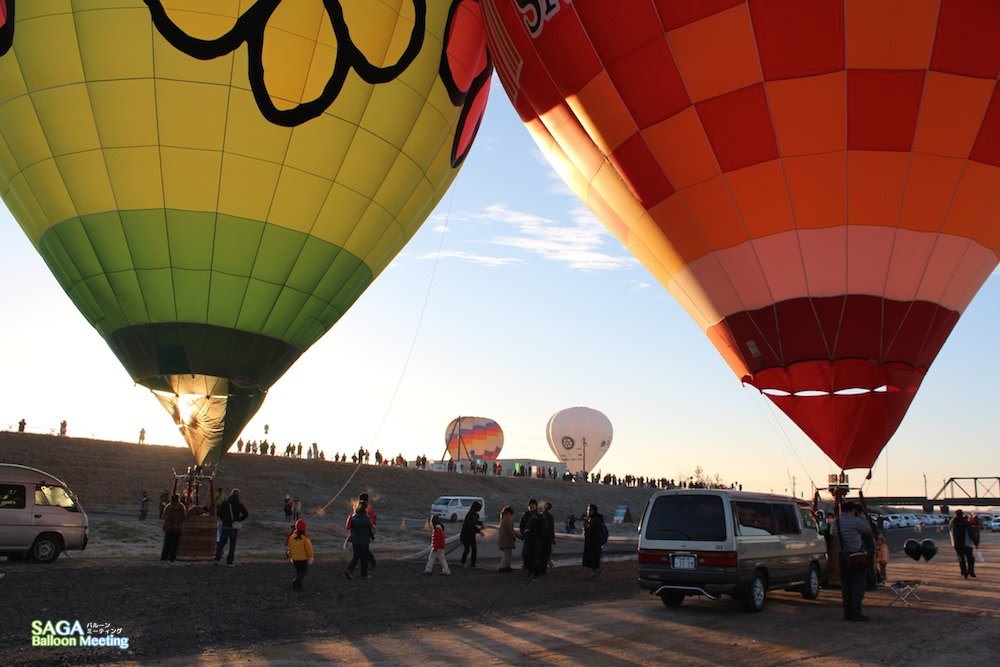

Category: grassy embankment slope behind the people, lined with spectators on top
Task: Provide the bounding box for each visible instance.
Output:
[0,431,652,525]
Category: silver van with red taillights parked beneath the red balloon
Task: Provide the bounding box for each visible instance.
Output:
[639,489,827,611]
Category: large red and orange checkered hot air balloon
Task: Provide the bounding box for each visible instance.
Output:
[482,0,1000,468]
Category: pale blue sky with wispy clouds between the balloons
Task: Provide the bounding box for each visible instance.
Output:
[0,74,1000,497]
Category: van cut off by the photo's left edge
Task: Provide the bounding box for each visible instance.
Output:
[0,463,89,563]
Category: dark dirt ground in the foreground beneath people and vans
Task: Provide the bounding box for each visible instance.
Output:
[0,520,1000,665]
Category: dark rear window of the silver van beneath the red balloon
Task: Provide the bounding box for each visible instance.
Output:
[646,495,726,542]
